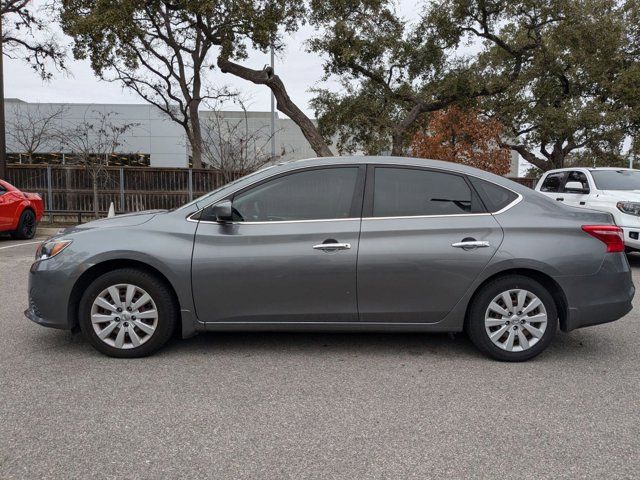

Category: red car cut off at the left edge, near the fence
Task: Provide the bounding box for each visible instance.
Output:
[0,180,44,239]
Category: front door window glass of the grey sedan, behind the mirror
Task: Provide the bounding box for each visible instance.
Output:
[233,167,358,222]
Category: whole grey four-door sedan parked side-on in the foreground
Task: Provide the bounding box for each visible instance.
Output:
[25,157,634,361]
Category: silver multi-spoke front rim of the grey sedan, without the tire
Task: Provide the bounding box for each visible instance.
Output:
[91,283,158,349]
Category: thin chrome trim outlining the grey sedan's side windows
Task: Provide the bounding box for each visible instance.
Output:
[187,162,524,225]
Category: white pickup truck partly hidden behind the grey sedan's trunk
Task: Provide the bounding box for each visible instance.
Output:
[536,168,640,251]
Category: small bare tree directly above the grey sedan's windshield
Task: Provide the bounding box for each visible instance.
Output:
[203,98,274,183]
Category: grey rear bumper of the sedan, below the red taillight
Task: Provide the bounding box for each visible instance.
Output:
[555,253,635,332]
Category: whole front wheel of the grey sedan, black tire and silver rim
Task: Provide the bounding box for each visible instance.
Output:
[78,268,178,358]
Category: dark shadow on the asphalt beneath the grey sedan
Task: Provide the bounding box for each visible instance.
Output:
[27,318,617,362]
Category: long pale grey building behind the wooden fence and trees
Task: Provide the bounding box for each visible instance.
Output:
[5,98,519,173]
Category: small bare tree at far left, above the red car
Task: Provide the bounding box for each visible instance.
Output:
[7,105,66,163]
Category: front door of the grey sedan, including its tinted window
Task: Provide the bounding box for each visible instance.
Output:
[192,166,365,323]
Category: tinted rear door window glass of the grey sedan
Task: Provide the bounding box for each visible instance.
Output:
[373,167,472,217]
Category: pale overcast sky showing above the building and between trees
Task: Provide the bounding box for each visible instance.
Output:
[4,0,420,115]
